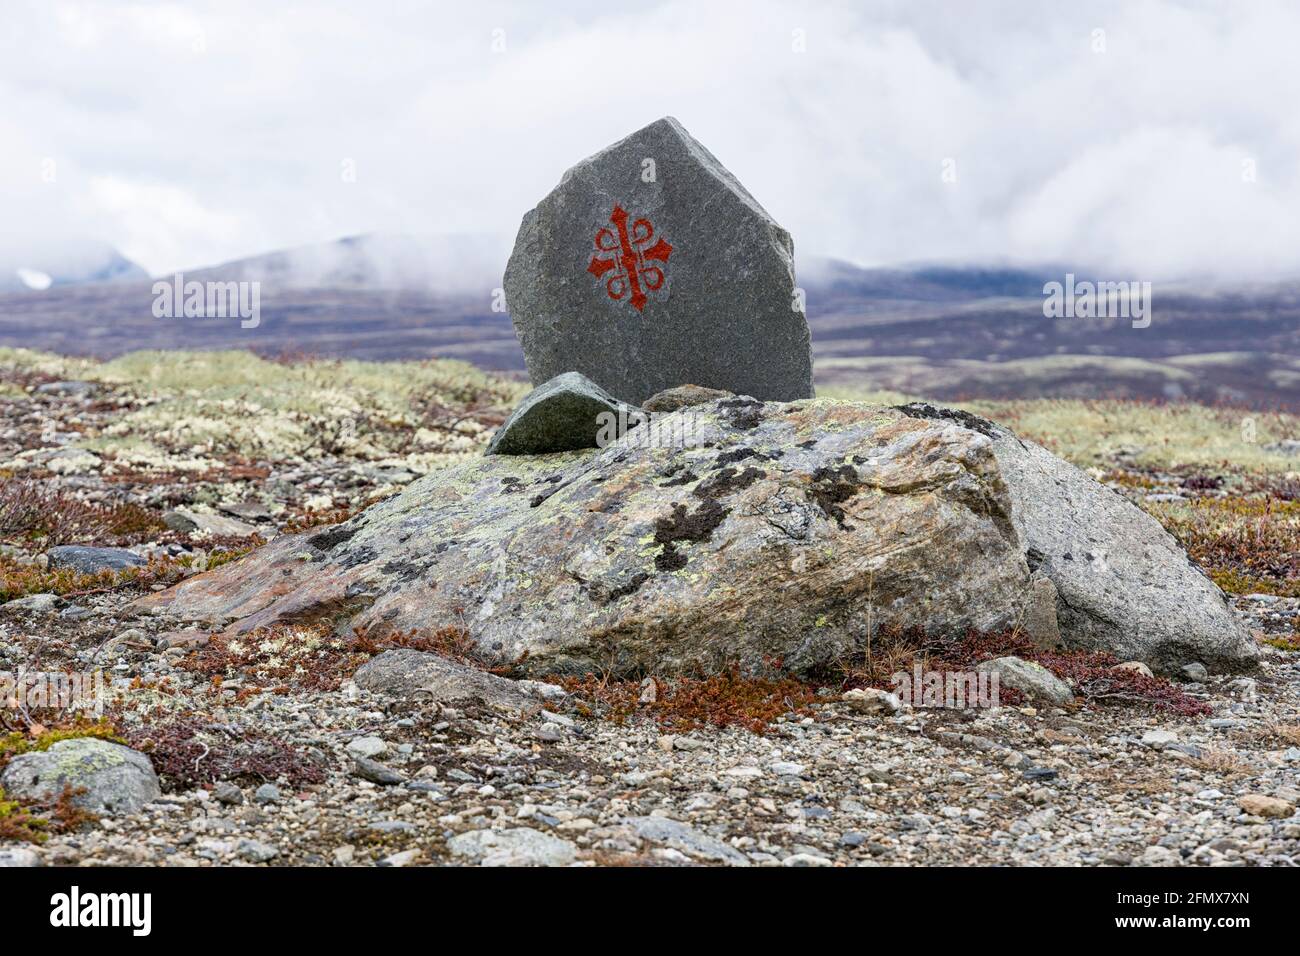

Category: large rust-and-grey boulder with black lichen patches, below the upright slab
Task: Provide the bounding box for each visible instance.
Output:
[134,398,1031,672]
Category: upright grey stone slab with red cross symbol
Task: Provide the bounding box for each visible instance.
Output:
[504,117,813,405]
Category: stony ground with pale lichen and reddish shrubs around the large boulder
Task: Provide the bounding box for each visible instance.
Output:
[0,352,1300,866]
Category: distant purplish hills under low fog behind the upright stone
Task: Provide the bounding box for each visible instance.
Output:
[0,234,1300,408]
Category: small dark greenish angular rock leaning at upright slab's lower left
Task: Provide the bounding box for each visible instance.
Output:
[484,372,645,455]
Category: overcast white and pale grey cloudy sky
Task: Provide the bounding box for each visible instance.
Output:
[0,0,1300,280]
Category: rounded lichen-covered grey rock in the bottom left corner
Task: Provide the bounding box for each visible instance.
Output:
[0,737,163,816]
